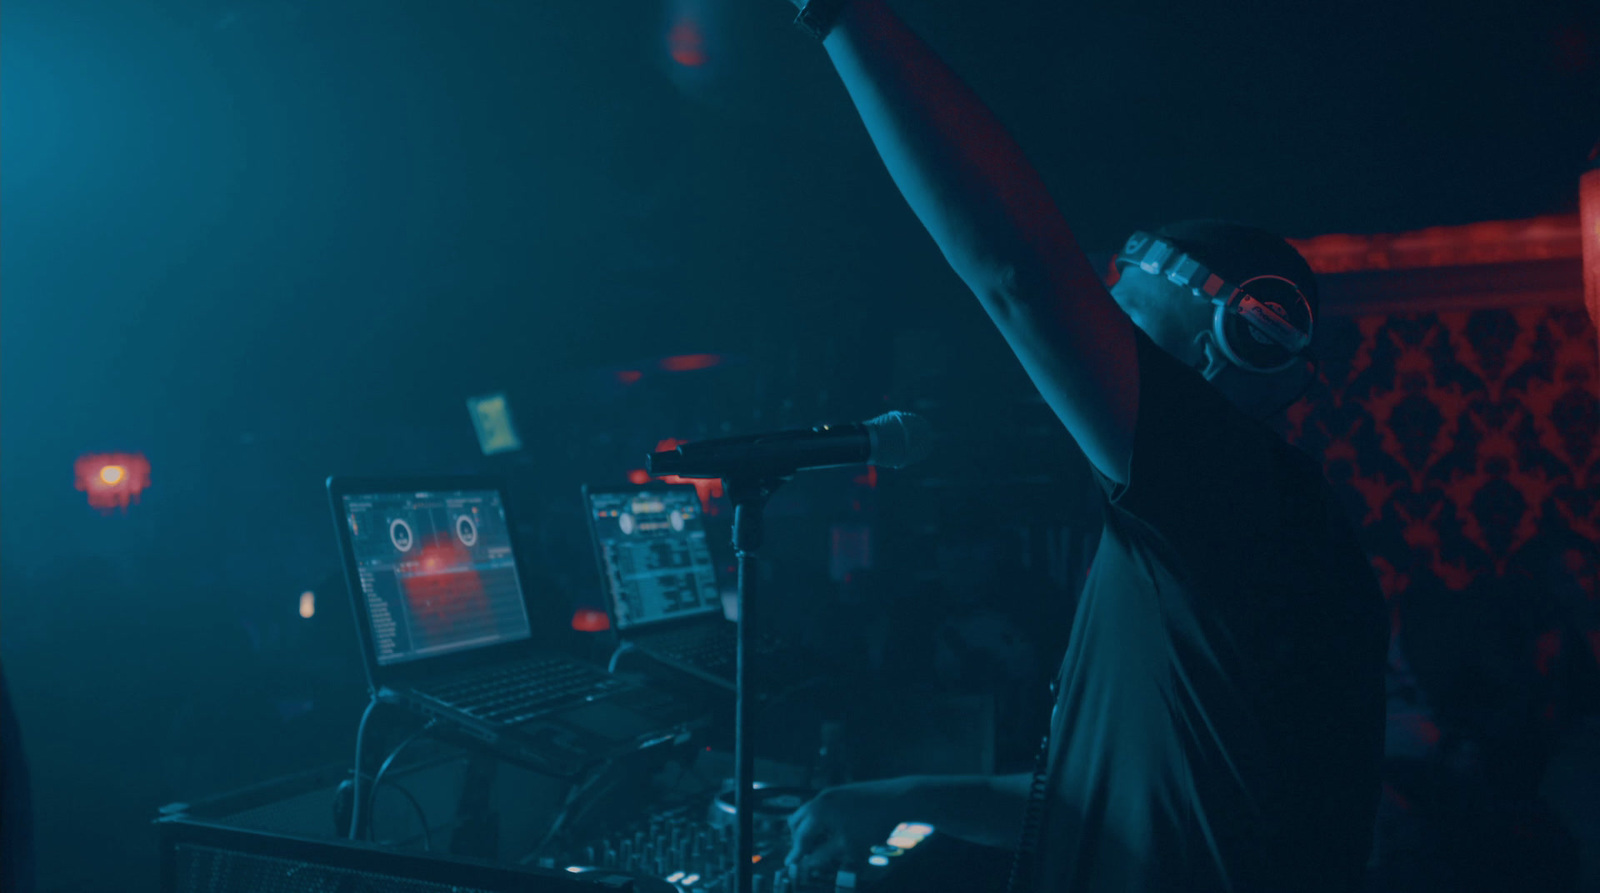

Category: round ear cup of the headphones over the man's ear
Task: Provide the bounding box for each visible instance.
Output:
[1211,275,1314,373]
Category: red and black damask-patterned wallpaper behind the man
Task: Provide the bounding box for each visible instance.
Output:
[1285,306,1600,597]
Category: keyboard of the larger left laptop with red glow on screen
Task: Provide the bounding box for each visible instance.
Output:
[424,658,630,725]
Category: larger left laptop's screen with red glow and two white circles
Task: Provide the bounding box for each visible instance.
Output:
[342,490,530,664]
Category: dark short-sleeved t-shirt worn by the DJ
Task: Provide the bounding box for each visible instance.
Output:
[1037,331,1389,893]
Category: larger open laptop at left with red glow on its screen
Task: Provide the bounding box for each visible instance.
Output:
[328,477,698,778]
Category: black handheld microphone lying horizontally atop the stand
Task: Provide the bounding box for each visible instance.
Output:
[645,411,933,477]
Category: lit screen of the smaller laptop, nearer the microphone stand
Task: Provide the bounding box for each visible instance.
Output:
[589,487,722,631]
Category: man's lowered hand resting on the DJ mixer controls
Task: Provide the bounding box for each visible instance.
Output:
[784,778,925,877]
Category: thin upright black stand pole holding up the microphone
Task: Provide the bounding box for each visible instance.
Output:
[723,477,786,893]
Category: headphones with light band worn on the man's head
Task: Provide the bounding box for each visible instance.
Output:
[1115,232,1315,379]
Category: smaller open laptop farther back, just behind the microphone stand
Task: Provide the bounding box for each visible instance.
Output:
[584,483,819,695]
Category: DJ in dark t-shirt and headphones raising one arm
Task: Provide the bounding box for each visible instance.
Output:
[789,0,1387,893]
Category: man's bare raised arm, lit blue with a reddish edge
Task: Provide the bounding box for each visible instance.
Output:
[812,0,1139,483]
